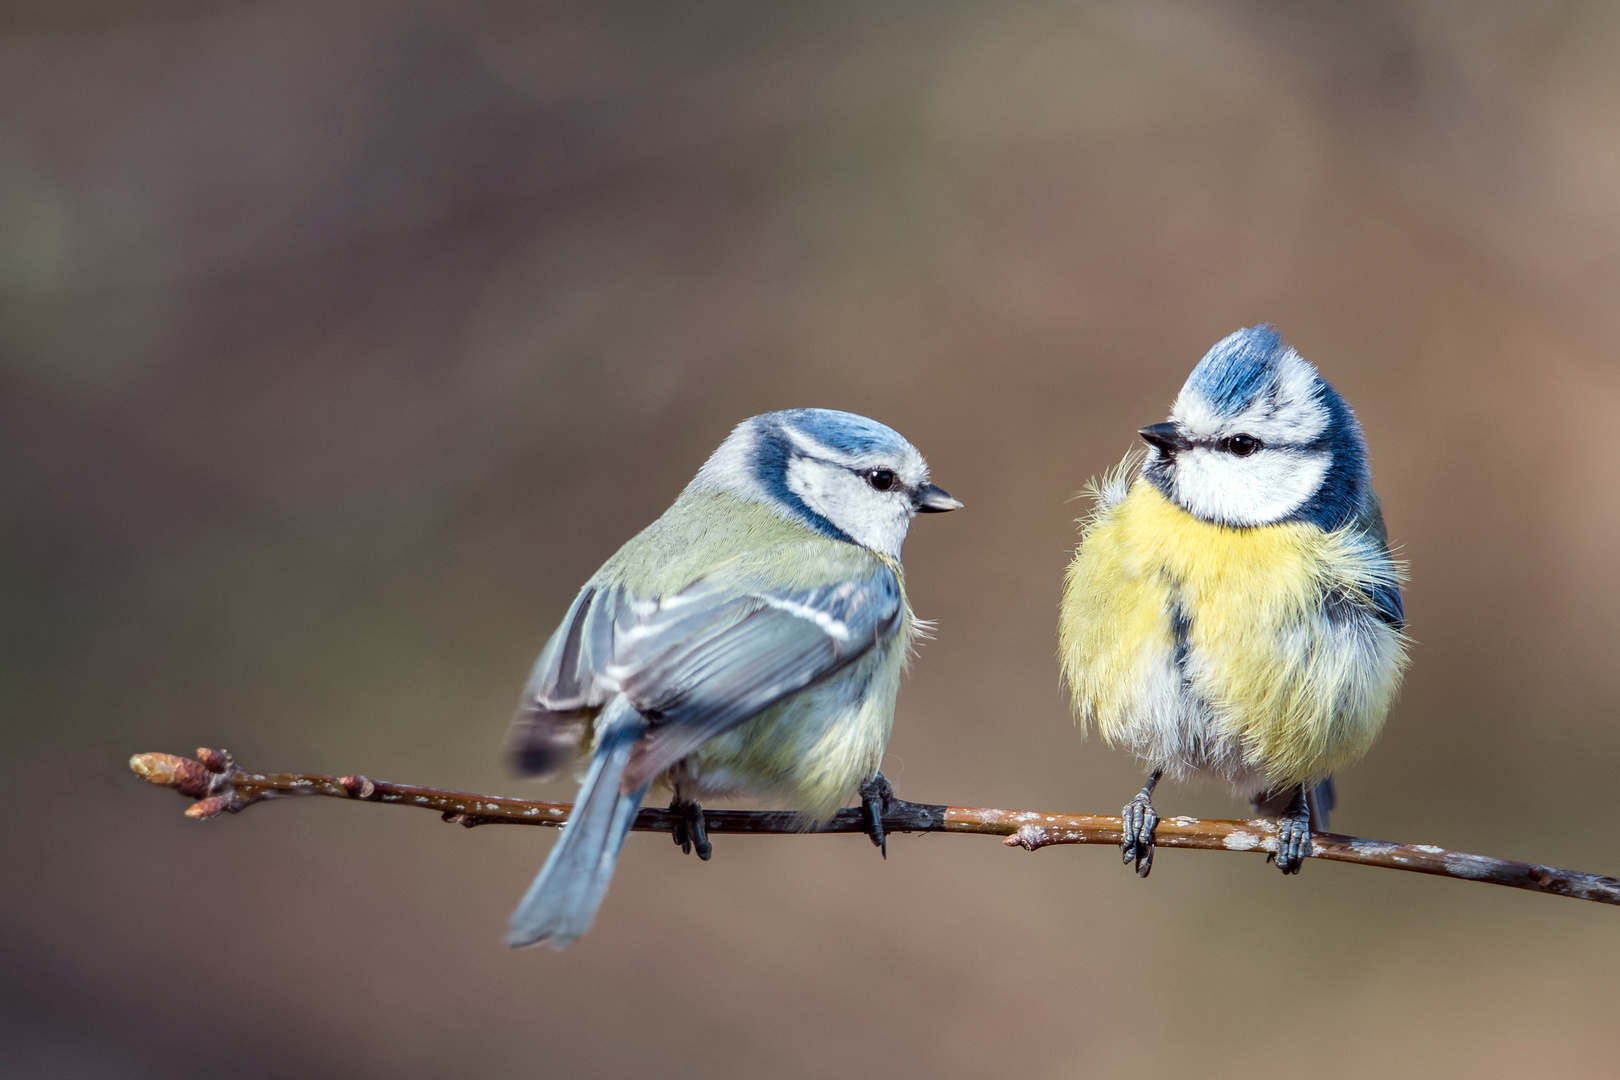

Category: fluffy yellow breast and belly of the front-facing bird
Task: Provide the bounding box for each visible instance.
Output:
[1059,479,1406,785]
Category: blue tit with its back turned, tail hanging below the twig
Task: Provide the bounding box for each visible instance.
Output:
[507,408,962,949]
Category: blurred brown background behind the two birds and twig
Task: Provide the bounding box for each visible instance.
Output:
[0,0,1620,1078]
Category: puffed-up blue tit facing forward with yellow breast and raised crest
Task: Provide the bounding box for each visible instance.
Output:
[1059,325,1406,876]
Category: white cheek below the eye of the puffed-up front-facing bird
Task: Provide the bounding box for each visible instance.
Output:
[1176,447,1330,525]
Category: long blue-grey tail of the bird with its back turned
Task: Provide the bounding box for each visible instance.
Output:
[507,698,646,949]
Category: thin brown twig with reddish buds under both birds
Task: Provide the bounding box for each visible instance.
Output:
[130,750,1620,904]
